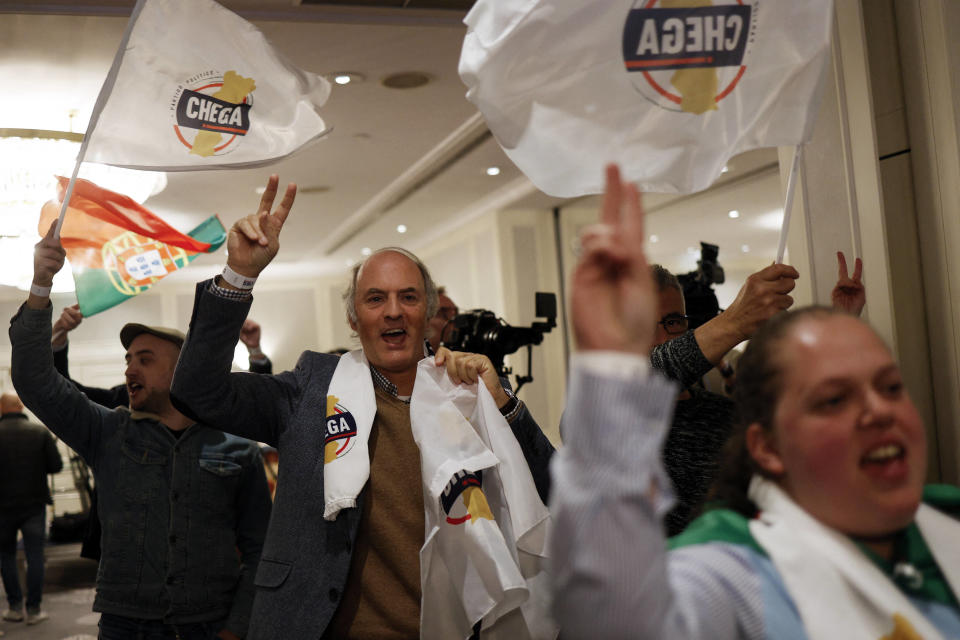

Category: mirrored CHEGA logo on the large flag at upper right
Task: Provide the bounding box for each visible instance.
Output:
[623,0,758,115]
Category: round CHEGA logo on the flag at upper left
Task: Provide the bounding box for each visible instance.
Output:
[170,71,257,157]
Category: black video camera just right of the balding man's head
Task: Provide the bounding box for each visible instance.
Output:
[443,291,557,392]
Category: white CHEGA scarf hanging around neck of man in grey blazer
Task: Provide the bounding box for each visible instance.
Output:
[323,351,557,640]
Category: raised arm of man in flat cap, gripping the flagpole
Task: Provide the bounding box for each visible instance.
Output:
[10,224,109,467]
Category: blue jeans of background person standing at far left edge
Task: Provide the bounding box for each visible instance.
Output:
[0,504,47,612]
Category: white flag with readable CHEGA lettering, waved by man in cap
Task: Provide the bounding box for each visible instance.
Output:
[81,0,330,171]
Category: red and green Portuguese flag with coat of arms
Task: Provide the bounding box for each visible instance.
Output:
[39,176,227,317]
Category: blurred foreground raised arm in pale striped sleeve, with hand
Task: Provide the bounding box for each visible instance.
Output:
[551,167,752,640]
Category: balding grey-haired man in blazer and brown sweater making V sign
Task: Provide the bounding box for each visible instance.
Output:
[172,176,553,639]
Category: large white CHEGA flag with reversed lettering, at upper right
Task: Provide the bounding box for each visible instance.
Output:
[460,0,833,197]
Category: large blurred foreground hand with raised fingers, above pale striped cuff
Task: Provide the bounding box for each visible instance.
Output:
[571,165,657,356]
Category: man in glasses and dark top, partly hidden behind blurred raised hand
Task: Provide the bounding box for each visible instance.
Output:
[650,264,799,536]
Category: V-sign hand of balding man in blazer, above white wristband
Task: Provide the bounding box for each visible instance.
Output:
[227,174,297,278]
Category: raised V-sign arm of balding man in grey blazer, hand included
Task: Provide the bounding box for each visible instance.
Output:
[171,175,299,446]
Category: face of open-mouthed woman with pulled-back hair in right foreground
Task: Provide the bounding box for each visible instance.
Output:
[755,316,927,537]
